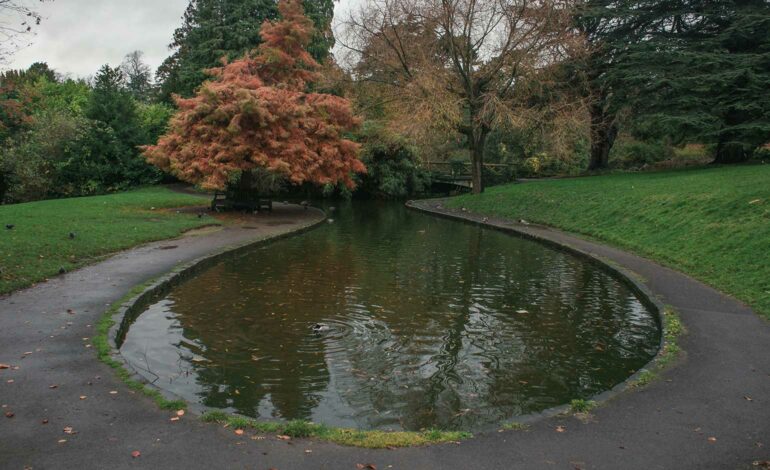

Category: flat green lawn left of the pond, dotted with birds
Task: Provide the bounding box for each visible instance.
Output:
[0,187,217,293]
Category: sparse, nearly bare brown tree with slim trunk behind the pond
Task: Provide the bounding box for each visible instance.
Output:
[340,0,577,193]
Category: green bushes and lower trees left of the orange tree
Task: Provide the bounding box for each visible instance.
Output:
[0,53,173,203]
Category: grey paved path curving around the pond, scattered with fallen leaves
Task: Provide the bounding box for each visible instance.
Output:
[0,202,770,470]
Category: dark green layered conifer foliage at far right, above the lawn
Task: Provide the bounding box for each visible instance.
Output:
[611,0,770,163]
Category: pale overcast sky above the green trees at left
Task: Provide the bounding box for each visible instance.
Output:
[3,0,354,77]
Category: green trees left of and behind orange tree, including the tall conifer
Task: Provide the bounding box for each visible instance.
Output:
[0,0,334,203]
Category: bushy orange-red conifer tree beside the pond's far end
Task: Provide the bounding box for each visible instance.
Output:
[144,0,366,193]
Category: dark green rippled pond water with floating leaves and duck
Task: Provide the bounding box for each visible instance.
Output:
[121,203,660,430]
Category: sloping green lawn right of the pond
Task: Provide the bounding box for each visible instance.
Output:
[447,164,770,319]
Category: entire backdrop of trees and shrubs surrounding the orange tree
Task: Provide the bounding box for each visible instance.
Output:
[0,0,770,202]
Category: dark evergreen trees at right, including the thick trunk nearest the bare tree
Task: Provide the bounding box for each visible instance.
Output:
[571,0,770,168]
